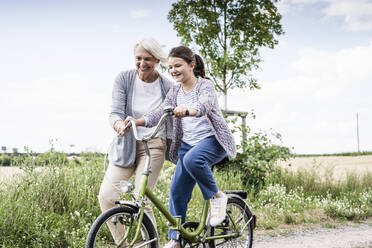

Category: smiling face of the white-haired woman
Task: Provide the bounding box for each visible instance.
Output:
[134,45,159,76]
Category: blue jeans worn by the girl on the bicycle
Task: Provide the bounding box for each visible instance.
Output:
[168,136,226,239]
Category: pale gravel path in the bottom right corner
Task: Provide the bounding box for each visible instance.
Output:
[253,223,372,248]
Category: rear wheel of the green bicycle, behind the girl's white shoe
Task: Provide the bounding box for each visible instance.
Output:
[209,195,254,248]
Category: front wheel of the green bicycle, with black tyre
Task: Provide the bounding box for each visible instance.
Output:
[85,207,158,248]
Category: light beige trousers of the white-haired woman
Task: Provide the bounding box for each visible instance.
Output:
[98,138,166,243]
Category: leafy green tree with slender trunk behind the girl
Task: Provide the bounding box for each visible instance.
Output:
[168,0,284,110]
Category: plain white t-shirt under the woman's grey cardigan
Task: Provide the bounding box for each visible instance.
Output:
[132,75,165,138]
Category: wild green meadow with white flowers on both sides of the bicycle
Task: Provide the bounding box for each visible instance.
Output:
[0,151,372,248]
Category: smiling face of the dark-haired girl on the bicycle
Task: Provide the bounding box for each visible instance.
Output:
[168,57,195,83]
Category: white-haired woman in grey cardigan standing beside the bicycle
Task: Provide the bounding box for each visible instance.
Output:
[98,38,173,244]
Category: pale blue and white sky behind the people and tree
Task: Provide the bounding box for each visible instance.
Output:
[0,0,372,154]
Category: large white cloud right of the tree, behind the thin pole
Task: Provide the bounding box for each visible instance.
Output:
[229,42,372,153]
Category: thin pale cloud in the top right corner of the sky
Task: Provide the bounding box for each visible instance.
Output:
[278,0,372,31]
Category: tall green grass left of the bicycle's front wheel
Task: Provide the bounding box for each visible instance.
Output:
[0,156,103,247]
